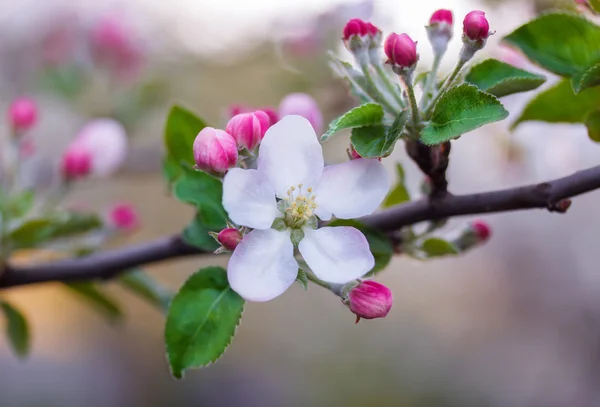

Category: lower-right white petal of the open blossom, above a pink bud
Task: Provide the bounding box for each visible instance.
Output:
[298,226,375,284]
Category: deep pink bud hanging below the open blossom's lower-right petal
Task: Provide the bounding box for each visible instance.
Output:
[347,280,393,322]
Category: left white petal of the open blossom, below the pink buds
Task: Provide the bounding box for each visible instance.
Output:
[223,168,280,229]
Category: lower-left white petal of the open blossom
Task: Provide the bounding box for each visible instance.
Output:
[227,229,298,301]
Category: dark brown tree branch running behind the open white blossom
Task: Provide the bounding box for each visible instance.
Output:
[0,166,600,288]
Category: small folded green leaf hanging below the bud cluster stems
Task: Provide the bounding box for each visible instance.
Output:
[350,110,408,158]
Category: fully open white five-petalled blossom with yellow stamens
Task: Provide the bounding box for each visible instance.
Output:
[223,116,389,301]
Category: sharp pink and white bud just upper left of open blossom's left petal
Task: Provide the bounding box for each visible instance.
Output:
[194,127,238,173]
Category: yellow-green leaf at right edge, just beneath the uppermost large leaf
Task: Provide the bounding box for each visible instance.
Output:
[512,79,600,128]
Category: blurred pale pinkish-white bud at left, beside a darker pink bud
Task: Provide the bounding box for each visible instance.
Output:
[72,119,128,177]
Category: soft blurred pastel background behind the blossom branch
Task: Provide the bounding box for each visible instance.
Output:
[0,0,600,407]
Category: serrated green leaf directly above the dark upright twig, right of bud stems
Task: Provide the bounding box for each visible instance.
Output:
[421,83,508,145]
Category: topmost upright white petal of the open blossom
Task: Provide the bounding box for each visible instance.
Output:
[258,116,324,198]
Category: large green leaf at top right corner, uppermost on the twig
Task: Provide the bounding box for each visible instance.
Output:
[504,13,600,77]
